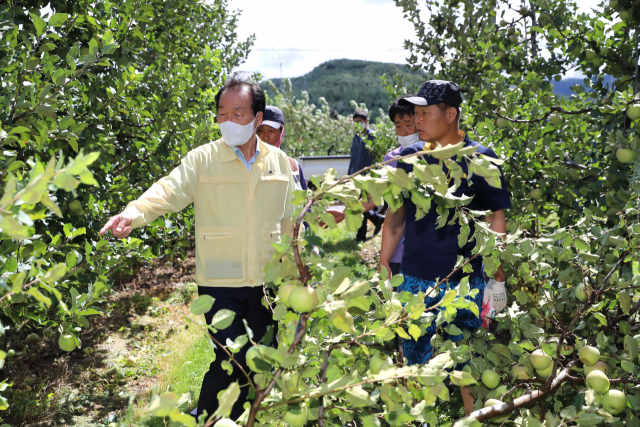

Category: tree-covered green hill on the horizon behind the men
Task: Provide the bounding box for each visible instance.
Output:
[262,59,425,115]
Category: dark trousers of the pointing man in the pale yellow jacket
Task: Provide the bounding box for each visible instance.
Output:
[198,286,276,420]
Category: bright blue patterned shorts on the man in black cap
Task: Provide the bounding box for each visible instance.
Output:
[397,275,486,365]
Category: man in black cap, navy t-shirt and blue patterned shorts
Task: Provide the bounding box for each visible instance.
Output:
[380,80,511,414]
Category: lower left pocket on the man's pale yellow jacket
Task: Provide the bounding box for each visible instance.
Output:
[198,228,246,280]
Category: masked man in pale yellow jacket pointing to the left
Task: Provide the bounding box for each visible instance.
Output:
[100,74,294,419]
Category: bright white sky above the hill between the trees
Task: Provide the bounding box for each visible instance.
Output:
[225,0,600,78]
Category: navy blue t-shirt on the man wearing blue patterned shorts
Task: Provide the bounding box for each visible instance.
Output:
[398,135,511,282]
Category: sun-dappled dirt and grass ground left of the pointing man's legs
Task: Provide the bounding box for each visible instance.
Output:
[1,252,197,427]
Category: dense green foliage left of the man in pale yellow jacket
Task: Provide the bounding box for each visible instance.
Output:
[0,0,252,413]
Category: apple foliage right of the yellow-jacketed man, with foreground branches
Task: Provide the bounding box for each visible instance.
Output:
[155,0,640,427]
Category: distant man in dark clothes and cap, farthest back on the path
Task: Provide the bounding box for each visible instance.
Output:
[347,110,384,242]
